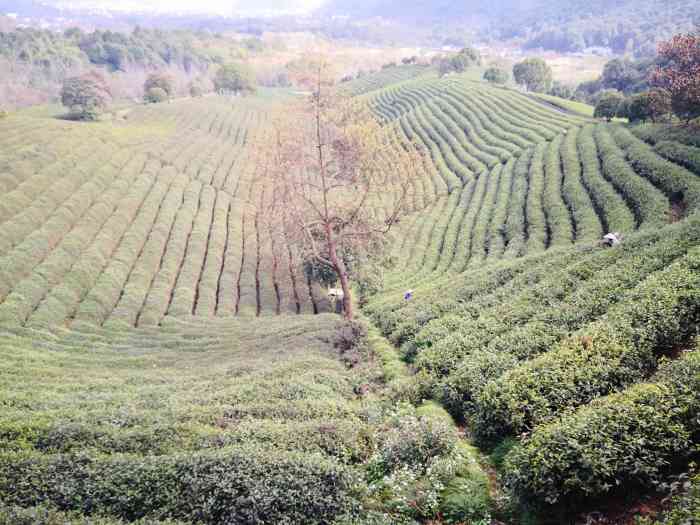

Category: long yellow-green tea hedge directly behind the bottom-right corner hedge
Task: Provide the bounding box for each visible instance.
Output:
[475,249,700,441]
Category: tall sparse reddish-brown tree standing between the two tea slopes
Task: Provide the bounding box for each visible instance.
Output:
[260,59,422,319]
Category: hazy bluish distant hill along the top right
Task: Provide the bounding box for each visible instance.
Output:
[322,0,700,55]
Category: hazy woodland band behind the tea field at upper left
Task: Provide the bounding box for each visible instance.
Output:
[0,27,265,107]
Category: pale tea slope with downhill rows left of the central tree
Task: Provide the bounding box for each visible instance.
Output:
[0,94,332,326]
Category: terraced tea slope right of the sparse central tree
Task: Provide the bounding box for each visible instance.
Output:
[363,72,700,523]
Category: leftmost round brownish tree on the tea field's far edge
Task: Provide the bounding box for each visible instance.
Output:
[61,72,112,120]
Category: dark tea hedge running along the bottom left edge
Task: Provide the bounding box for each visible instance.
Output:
[0,448,356,524]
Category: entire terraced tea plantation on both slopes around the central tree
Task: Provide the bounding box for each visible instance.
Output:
[0,67,700,524]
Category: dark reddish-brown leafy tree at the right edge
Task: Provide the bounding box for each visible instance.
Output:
[651,34,700,122]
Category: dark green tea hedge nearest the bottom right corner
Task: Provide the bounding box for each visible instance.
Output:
[505,351,700,505]
